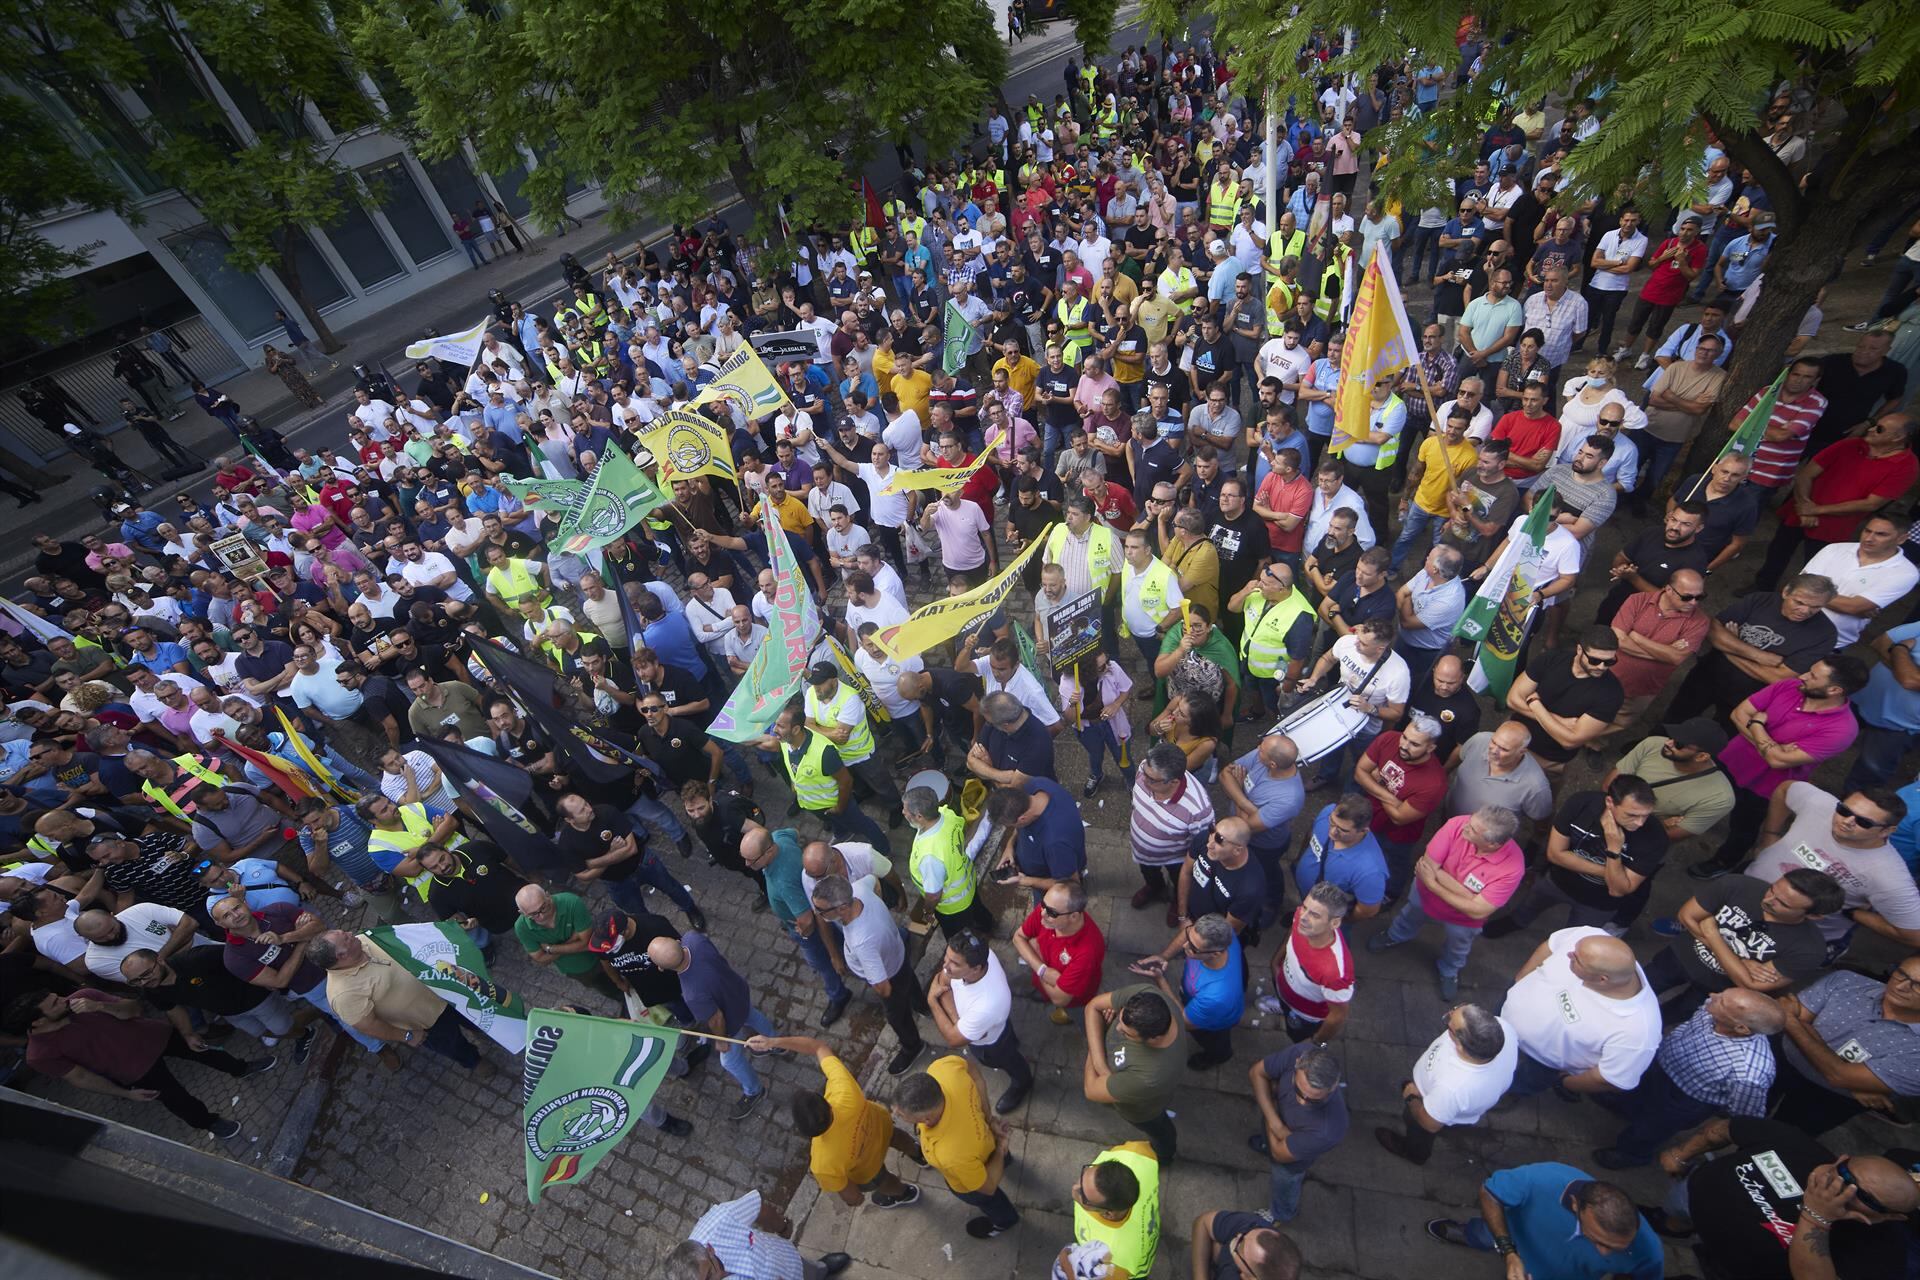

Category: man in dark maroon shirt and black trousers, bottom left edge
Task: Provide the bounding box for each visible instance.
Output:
[0,986,275,1138]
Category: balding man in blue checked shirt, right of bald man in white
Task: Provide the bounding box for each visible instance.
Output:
[1594,986,1788,1169]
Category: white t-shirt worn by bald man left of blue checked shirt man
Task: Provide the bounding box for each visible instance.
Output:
[1500,927,1661,1092]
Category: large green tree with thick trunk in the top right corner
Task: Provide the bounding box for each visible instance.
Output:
[1148,0,1920,445]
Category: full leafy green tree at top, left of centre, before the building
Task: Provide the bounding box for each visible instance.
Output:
[346,0,1116,266]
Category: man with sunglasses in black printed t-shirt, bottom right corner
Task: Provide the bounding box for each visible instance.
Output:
[1647,1117,1920,1280]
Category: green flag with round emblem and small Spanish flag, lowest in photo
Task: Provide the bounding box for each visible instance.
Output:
[520,1009,680,1205]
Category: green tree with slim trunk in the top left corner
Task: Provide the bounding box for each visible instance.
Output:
[0,0,393,351]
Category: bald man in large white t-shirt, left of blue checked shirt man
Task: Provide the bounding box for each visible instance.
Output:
[1500,927,1661,1102]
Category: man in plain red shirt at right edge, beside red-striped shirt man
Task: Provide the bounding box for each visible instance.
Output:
[1747,413,1920,591]
